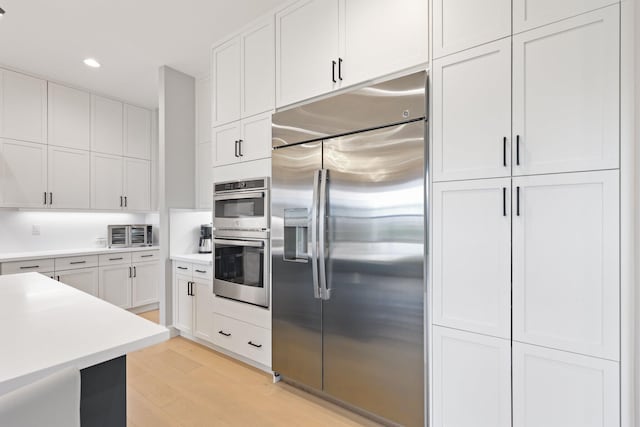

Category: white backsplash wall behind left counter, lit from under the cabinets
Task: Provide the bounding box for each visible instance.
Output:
[0,210,151,253]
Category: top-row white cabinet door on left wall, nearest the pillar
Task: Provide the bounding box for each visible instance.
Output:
[124,104,151,160]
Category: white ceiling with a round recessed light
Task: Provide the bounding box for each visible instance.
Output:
[0,0,283,107]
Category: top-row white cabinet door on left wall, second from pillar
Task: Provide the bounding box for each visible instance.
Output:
[91,95,124,156]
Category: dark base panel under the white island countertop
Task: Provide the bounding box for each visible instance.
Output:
[80,356,127,427]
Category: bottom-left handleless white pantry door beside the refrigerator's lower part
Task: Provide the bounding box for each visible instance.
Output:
[432,326,510,427]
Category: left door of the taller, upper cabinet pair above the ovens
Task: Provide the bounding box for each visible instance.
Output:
[211,37,241,126]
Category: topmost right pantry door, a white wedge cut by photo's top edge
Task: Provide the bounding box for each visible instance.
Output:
[513,0,617,33]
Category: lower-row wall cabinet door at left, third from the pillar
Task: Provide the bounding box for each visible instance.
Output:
[47,146,91,209]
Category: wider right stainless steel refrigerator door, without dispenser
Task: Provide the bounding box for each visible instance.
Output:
[321,121,425,425]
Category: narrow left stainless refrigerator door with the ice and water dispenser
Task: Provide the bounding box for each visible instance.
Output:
[271,142,322,390]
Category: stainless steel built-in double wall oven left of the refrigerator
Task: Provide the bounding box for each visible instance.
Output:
[213,178,270,307]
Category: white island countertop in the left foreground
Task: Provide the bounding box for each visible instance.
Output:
[0,273,169,395]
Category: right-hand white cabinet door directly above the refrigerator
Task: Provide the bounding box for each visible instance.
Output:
[340,0,429,86]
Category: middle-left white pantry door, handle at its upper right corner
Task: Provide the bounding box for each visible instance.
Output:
[433,178,511,339]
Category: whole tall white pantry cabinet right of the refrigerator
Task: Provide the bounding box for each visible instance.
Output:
[431,0,620,427]
